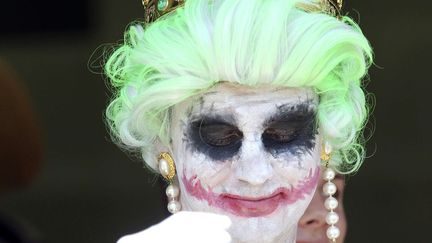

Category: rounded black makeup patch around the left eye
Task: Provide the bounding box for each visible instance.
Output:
[188,117,243,160]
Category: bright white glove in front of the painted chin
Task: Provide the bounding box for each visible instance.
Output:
[117,211,231,243]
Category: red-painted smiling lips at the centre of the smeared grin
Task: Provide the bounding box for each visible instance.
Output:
[219,188,288,217]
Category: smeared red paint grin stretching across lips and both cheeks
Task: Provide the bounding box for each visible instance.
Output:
[182,167,320,217]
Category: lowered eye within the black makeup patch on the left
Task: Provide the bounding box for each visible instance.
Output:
[199,123,243,147]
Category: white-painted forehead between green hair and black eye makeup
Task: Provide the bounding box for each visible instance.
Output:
[196,83,318,115]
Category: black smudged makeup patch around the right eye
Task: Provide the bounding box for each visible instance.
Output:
[262,102,317,156]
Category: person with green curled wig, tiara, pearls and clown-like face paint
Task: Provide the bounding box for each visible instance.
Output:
[105,0,372,243]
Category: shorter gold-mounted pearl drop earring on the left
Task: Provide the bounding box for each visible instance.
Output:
[158,152,181,214]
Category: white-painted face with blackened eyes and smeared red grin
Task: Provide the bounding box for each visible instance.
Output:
[171,83,320,242]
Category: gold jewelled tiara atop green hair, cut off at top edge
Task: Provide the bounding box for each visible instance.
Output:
[142,0,343,24]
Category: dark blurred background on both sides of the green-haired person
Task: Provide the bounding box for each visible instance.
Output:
[0,0,432,243]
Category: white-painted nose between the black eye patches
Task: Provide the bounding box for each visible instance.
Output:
[233,136,273,186]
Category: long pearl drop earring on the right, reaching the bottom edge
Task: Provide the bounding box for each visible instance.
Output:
[321,143,340,242]
